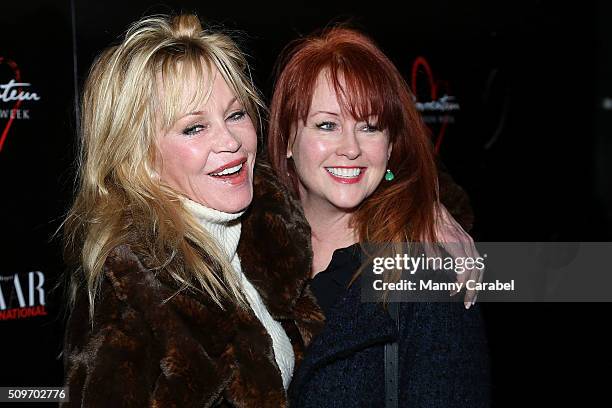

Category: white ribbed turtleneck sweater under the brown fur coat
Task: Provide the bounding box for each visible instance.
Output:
[183,199,295,389]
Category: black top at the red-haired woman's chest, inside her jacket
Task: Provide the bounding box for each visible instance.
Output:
[310,244,361,315]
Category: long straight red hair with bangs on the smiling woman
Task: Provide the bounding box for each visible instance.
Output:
[268,27,437,243]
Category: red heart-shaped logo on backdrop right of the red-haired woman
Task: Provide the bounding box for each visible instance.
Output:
[410,57,460,153]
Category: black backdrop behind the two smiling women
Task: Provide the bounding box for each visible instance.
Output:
[0,0,612,406]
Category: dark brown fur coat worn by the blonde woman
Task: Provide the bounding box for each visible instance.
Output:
[64,166,323,408]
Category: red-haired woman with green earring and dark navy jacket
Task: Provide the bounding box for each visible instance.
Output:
[268,28,489,407]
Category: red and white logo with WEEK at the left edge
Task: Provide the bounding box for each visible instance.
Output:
[0,57,40,152]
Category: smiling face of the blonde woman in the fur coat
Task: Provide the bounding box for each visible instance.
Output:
[155,65,257,213]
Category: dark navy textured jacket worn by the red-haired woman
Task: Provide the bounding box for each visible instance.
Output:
[289,272,490,408]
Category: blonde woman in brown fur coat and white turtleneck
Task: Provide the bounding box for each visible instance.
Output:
[64,15,323,407]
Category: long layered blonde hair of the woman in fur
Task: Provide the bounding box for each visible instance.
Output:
[63,15,263,317]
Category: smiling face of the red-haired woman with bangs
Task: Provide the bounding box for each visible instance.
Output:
[287,72,391,211]
